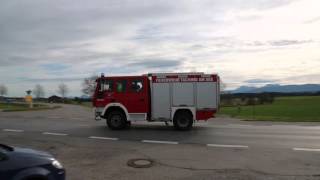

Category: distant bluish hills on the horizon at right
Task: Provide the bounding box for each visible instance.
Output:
[231,84,320,93]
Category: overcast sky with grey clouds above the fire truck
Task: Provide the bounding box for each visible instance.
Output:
[0,0,320,96]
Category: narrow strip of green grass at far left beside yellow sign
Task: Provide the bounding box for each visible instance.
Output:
[0,103,60,112]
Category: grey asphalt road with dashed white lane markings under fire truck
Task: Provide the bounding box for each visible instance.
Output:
[0,105,320,180]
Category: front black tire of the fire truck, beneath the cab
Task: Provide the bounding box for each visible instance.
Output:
[107,111,127,130]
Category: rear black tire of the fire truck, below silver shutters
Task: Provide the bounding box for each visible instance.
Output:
[173,111,193,131]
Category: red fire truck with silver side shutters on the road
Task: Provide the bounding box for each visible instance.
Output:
[93,73,220,130]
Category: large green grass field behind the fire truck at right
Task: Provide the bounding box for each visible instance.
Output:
[219,96,320,121]
